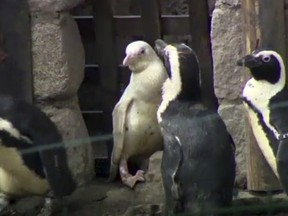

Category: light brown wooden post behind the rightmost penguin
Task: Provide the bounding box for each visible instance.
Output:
[242,0,281,192]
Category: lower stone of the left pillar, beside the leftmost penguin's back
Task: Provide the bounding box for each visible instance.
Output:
[39,99,94,185]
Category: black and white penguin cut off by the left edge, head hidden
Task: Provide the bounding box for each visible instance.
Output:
[0,95,76,215]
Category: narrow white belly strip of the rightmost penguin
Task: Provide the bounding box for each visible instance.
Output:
[245,104,279,177]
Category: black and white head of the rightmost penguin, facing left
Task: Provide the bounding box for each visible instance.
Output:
[237,50,285,84]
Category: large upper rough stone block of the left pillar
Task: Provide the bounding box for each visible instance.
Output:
[31,12,85,100]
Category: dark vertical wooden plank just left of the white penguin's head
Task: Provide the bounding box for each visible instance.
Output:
[92,0,120,160]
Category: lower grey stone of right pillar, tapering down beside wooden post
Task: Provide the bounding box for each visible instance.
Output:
[218,104,247,189]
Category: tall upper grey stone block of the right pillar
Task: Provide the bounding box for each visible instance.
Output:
[211,0,245,100]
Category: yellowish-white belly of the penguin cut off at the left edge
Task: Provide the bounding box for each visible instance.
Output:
[0,145,49,196]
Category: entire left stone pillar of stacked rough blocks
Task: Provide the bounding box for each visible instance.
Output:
[28,0,94,184]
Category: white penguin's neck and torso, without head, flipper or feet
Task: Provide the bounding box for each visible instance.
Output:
[118,62,164,159]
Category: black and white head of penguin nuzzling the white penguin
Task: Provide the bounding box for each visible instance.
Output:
[155,39,201,100]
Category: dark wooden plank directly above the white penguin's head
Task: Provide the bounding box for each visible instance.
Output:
[141,0,161,47]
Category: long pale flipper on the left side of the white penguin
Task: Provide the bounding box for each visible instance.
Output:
[108,96,133,181]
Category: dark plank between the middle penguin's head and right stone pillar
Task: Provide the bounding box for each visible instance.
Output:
[188,0,218,109]
